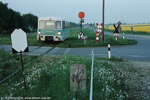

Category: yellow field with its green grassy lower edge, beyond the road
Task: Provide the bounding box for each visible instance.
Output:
[105,24,150,35]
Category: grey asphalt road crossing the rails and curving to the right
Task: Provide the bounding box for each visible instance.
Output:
[0,32,150,61]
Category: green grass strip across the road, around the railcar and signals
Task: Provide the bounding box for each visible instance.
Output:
[0,29,137,48]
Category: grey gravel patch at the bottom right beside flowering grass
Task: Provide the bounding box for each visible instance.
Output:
[124,61,150,100]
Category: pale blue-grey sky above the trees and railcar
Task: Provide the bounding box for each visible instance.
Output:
[1,0,150,24]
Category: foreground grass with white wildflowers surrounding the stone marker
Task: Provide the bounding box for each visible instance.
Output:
[0,51,128,100]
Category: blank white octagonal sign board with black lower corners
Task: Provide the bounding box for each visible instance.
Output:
[11,29,29,53]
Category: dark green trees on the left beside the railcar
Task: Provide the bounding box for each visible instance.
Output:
[0,1,38,34]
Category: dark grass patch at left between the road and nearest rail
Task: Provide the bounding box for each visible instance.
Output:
[0,49,36,80]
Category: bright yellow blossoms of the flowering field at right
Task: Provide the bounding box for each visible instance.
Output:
[106,24,150,33]
